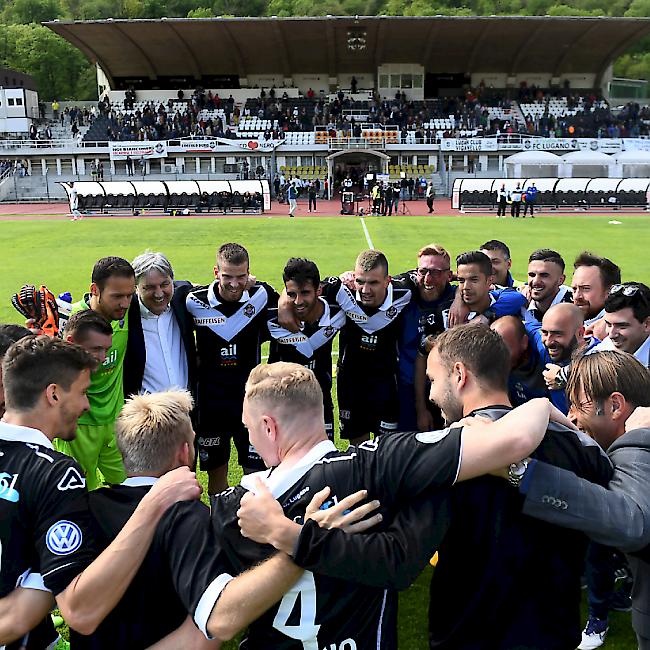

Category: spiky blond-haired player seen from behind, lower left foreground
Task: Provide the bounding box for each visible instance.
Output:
[71,390,300,650]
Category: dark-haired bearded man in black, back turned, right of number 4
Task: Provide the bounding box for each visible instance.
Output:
[427,325,610,650]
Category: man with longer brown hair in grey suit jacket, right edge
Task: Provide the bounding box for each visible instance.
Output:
[508,351,650,650]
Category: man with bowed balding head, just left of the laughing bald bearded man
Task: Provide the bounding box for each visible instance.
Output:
[490,316,549,406]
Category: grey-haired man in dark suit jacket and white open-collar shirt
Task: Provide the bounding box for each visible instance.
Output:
[124,251,196,397]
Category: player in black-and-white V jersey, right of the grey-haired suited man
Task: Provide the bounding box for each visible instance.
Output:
[185,243,278,494]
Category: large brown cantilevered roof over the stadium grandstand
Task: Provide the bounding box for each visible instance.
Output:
[45,16,650,85]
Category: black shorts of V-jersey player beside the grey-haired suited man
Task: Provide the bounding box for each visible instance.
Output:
[196,405,266,472]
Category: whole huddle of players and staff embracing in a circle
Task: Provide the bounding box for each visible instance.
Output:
[0,240,650,650]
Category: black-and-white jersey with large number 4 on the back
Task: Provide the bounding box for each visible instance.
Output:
[212,429,462,650]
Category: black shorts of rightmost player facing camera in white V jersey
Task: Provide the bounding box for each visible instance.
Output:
[336,368,399,440]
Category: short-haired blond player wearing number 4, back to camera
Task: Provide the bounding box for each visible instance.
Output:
[212,362,568,650]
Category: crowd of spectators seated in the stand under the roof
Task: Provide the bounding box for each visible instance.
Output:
[22,83,650,143]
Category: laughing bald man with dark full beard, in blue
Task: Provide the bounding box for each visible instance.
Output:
[526,302,597,413]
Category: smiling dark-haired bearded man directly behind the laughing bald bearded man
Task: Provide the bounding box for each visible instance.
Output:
[522,248,572,324]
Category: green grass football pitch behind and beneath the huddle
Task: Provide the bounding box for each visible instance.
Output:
[0,215,650,650]
